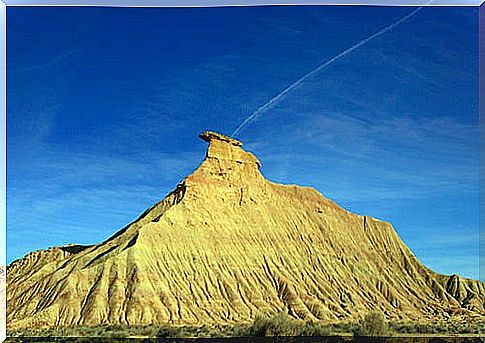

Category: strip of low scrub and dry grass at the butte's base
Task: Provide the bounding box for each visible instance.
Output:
[7,312,485,342]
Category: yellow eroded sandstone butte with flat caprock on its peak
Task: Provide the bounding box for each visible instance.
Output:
[7,132,485,329]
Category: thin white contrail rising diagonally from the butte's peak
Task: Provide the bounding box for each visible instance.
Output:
[232,5,433,137]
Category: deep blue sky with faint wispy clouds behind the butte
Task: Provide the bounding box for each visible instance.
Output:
[7,6,479,278]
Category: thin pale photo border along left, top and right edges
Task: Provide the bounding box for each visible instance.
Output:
[0,0,485,342]
